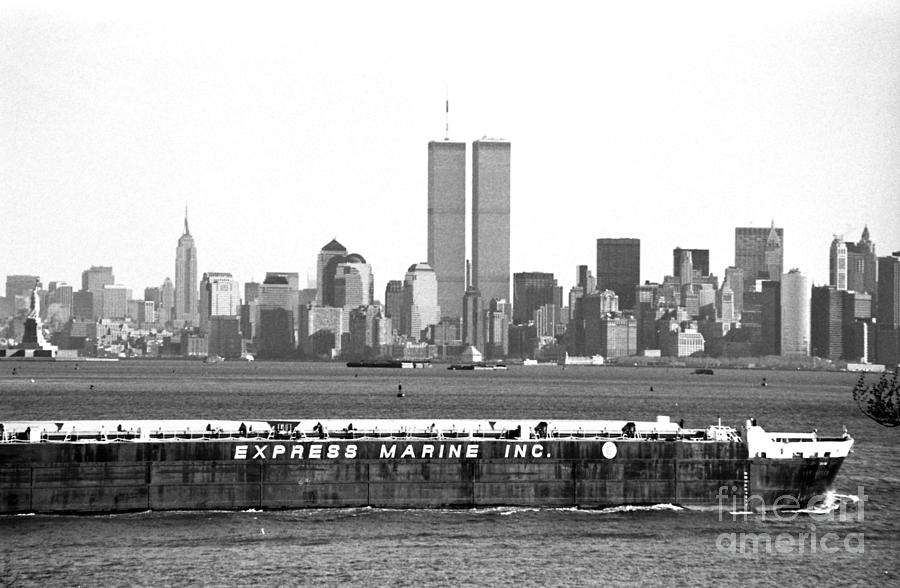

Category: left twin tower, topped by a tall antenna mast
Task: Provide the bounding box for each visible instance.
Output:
[428,141,466,318]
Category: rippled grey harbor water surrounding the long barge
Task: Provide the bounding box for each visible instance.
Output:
[0,361,900,586]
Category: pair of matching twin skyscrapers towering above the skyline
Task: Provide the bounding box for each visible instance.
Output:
[428,138,510,317]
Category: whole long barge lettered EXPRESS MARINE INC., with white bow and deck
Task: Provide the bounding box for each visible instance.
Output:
[0,417,853,514]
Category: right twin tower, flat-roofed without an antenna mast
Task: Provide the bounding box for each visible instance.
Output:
[472,139,510,300]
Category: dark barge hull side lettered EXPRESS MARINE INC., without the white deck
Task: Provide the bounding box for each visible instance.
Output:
[0,438,843,514]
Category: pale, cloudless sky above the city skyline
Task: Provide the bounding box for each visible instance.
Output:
[0,0,900,298]
